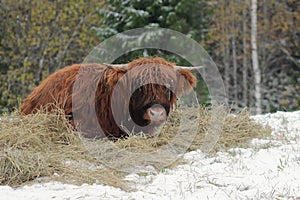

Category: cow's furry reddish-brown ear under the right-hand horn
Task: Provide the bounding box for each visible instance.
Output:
[176,69,197,96]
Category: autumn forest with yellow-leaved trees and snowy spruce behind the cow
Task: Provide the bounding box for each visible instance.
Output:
[0,0,300,114]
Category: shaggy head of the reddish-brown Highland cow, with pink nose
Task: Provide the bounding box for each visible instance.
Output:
[108,58,196,135]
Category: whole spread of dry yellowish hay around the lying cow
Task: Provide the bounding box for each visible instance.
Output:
[0,107,270,190]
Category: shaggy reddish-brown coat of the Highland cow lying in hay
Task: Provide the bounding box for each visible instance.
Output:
[20,57,196,138]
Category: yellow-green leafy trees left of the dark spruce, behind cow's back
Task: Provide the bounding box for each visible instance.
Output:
[0,0,101,112]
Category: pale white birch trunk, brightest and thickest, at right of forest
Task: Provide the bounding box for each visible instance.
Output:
[251,0,261,114]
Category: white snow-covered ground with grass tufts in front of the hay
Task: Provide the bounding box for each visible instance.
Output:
[0,111,300,200]
